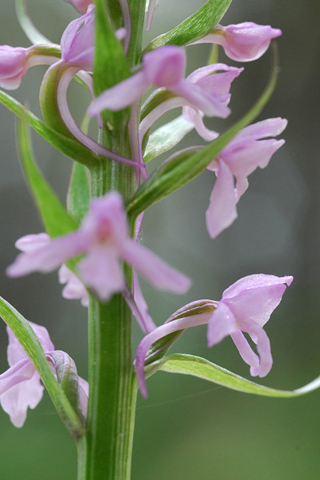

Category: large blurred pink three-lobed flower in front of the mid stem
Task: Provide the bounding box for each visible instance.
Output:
[7,192,190,300]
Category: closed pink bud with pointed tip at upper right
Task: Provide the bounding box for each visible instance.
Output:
[194,22,282,62]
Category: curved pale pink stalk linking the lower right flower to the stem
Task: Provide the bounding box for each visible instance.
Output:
[135,314,210,397]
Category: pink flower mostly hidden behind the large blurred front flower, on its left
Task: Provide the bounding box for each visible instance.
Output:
[15,233,89,307]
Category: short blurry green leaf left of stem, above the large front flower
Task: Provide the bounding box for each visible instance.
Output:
[67,163,90,223]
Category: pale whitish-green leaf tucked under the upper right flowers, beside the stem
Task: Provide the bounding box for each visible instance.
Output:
[143,115,194,163]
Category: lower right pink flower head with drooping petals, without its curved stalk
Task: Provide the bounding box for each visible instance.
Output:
[208,274,293,377]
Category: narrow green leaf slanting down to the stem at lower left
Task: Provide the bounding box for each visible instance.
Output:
[0,297,84,439]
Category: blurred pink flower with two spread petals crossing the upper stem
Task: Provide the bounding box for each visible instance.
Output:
[88,45,230,118]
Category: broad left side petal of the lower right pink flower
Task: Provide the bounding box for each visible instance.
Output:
[207,302,237,347]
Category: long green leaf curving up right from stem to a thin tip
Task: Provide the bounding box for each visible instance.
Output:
[127,47,277,218]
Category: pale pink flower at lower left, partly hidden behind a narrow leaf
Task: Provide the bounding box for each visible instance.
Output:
[0,322,89,427]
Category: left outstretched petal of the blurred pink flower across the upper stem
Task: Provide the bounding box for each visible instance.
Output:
[88,71,150,117]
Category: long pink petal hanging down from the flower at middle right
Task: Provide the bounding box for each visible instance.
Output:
[206,161,238,238]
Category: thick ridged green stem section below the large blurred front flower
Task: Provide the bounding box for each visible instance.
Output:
[84,295,136,480]
